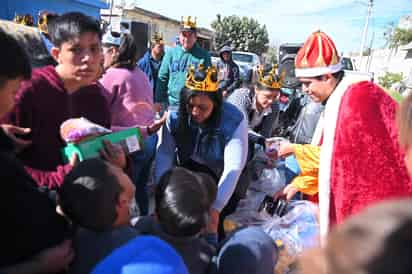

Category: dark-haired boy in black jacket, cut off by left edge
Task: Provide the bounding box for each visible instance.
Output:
[0,30,73,274]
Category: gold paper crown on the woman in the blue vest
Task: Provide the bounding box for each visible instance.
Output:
[185,64,219,92]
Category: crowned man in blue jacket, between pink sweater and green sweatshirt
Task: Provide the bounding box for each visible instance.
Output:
[137,32,165,94]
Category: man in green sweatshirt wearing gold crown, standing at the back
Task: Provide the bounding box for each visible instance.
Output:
[155,16,212,109]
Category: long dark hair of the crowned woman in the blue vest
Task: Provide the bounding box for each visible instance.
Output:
[177,87,223,147]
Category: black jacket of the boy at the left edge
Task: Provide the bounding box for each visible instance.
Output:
[0,128,69,268]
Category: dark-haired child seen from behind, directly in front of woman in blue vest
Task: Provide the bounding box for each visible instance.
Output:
[135,167,217,274]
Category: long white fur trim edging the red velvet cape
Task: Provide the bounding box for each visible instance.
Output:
[312,74,369,244]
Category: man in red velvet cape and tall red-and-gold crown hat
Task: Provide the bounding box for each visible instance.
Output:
[280,31,412,236]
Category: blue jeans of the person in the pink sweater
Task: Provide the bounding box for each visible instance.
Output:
[130,134,158,216]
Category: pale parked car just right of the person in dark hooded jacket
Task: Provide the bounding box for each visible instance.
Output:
[232,51,261,82]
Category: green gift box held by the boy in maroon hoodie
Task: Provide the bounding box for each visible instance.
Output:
[62,128,143,163]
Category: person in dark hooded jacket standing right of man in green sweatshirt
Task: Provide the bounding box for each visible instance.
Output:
[217,46,240,97]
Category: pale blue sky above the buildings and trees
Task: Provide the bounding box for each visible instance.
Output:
[122,0,412,52]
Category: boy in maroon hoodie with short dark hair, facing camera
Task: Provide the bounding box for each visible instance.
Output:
[2,12,126,188]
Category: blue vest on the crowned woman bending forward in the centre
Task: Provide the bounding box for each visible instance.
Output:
[169,102,244,177]
